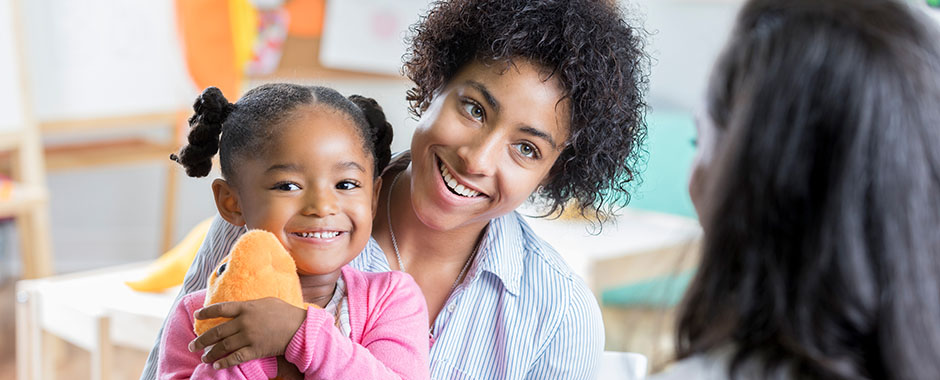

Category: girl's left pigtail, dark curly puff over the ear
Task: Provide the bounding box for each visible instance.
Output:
[170,87,235,177]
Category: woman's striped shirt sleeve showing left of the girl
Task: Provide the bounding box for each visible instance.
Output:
[140,214,245,380]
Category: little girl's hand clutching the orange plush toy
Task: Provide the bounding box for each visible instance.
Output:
[189,297,307,369]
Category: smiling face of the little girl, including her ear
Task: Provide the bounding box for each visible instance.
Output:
[213,105,380,275]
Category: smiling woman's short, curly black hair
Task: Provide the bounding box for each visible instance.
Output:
[404,0,650,223]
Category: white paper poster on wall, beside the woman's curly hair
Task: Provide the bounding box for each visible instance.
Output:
[320,0,430,75]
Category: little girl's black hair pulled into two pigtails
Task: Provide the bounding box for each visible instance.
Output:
[170,83,392,179]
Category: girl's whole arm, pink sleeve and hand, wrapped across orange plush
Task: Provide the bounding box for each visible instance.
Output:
[194,272,430,379]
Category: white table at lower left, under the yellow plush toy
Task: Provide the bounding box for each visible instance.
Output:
[16,263,179,380]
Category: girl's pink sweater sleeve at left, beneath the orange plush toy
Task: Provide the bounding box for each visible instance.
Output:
[157,291,277,380]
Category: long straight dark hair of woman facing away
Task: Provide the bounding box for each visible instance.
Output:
[677,0,940,379]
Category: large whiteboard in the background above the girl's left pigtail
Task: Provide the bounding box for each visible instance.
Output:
[18,0,195,121]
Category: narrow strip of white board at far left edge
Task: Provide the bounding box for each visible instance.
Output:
[0,0,23,132]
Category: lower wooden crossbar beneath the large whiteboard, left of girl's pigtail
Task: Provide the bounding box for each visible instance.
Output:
[46,138,179,171]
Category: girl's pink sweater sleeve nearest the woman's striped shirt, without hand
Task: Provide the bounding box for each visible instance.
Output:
[284,272,430,379]
